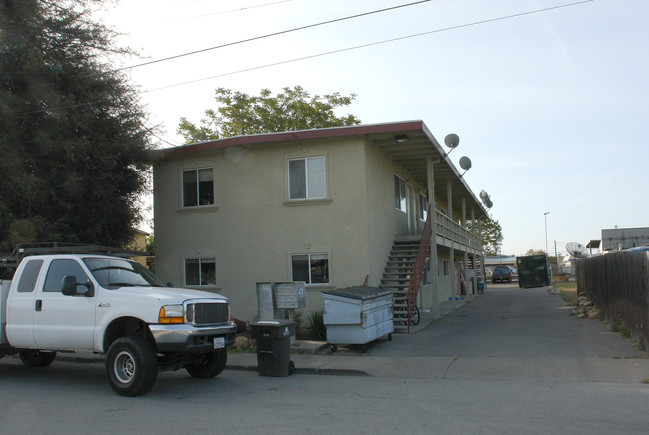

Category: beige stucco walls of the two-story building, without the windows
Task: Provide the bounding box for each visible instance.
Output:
[154,138,420,320]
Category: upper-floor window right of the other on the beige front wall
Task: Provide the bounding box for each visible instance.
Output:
[288,156,327,200]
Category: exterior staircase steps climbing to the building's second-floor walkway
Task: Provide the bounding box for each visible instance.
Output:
[379,236,420,332]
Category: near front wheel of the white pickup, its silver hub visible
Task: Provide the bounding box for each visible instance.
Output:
[106,337,158,397]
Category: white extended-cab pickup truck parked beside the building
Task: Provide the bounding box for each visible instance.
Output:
[0,254,236,396]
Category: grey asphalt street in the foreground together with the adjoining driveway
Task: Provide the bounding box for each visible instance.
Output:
[0,285,649,435]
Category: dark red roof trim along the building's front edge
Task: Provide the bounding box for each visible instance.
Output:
[161,121,430,157]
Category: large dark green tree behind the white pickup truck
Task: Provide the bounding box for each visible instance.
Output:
[0,0,153,251]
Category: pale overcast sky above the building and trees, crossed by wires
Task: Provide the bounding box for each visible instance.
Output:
[97,0,649,255]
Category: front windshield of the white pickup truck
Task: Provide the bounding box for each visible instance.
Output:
[83,258,165,289]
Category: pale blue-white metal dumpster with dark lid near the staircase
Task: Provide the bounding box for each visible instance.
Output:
[322,287,394,352]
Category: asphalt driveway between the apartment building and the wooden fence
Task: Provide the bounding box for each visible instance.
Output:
[368,284,647,358]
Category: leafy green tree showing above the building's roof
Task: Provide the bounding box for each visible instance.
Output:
[177,86,360,143]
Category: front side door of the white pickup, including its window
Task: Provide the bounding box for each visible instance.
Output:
[34,259,97,350]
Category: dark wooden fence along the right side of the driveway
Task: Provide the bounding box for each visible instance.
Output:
[576,252,649,345]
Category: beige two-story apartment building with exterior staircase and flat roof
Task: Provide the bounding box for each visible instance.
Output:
[154,121,486,330]
